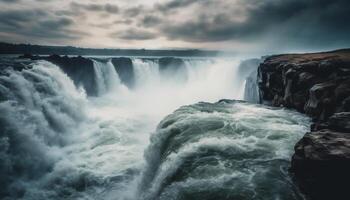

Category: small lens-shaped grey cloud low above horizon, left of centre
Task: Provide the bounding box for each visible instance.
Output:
[110,28,157,40]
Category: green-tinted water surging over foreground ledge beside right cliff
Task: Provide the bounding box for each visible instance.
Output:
[139,101,309,200]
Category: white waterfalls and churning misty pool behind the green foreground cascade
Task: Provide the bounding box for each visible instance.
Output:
[0,56,253,199]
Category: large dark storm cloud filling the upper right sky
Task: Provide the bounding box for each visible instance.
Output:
[154,0,350,47]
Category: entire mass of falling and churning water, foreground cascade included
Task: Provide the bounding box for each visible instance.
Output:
[0,58,309,200]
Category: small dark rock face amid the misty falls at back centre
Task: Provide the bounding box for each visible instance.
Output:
[158,57,187,80]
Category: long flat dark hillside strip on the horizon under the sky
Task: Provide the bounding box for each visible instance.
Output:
[0,42,220,57]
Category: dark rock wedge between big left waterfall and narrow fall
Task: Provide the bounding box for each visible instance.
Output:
[19,54,98,96]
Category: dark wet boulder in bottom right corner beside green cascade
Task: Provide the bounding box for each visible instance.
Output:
[292,130,350,200]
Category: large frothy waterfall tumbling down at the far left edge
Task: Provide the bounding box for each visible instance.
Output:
[0,60,87,199]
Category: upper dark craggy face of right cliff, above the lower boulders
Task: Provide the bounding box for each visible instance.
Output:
[258,51,350,115]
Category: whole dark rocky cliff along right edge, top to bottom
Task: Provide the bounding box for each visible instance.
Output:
[258,49,350,200]
